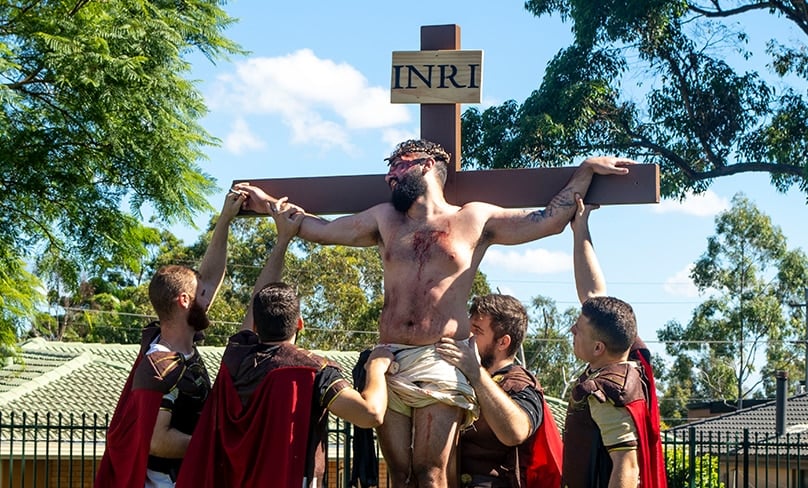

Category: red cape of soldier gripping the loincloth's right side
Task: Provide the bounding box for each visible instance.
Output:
[527,401,564,488]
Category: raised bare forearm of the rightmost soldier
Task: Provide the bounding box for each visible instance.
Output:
[570,195,606,303]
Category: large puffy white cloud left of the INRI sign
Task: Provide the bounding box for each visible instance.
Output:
[208,49,410,150]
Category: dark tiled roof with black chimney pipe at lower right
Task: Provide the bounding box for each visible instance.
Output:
[667,394,808,438]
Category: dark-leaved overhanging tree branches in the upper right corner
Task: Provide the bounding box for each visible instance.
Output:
[463,0,808,197]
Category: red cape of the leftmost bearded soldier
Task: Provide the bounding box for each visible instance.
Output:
[95,354,163,488]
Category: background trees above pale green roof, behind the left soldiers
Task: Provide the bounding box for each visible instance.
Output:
[30,218,498,351]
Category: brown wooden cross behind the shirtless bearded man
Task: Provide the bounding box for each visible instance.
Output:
[233,25,659,215]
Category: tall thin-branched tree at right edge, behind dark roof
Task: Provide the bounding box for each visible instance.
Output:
[658,194,808,413]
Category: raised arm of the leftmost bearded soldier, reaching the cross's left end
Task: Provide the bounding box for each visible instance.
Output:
[198,191,246,307]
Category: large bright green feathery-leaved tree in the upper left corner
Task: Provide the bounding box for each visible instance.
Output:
[0,0,240,346]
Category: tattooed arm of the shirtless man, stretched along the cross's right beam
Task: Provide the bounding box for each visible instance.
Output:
[485,156,636,244]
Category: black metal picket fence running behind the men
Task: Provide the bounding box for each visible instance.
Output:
[0,413,808,488]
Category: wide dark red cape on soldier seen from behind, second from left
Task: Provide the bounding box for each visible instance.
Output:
[176,365,315,488]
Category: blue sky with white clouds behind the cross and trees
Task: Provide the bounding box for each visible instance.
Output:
[177,0,808,366]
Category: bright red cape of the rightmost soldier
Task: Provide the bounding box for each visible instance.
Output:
[626,350,668,488]
